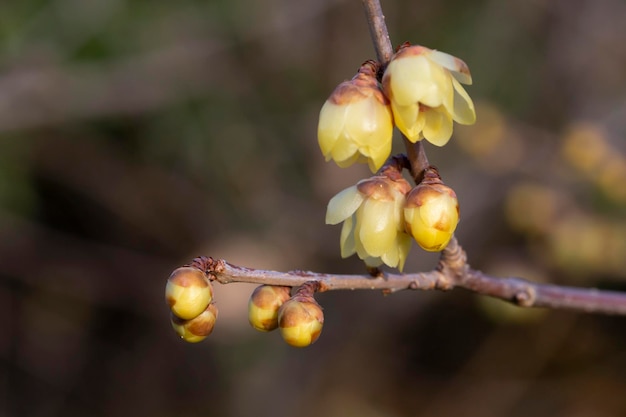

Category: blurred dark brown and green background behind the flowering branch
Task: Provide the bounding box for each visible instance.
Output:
[0,0,626,417]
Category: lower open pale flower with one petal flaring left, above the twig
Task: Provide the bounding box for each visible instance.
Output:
[326,175,411,270]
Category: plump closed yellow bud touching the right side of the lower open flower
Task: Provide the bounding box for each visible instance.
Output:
[404,172,459,252]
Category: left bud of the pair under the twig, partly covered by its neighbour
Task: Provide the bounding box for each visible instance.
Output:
[248,285,291,332]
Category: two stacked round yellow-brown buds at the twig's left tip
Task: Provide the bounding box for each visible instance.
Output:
[165,266,217,343]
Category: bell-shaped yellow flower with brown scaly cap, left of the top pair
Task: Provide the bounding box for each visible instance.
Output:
[317,61,393,172]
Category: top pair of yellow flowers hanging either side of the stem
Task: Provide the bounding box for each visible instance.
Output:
[318,43,476,172]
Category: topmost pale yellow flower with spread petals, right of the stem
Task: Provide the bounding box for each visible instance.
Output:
[383,45,476,146]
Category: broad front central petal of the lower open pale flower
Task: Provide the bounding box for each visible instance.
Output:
[355,199,396,256]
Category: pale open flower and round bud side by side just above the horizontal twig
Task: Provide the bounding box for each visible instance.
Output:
[326,166,459,270]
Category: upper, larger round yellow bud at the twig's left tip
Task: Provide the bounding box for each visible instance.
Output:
[165,266,213,320]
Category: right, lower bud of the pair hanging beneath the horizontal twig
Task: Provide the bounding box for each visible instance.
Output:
[278,295,324,347]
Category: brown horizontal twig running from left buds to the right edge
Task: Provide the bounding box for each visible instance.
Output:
[185,254,626,315]
